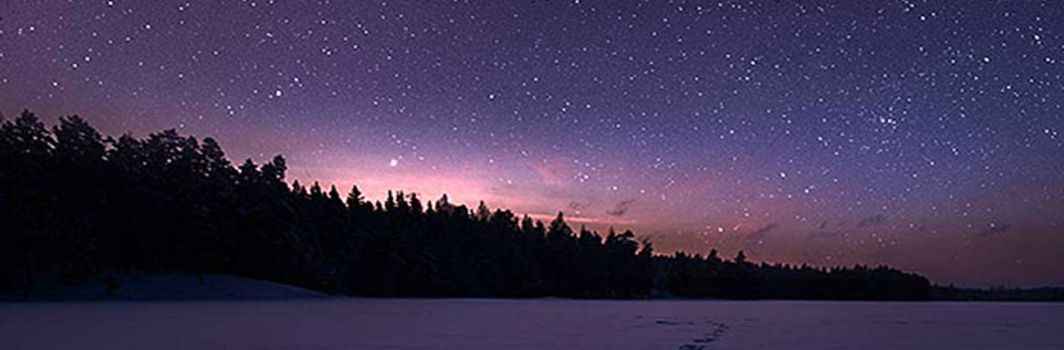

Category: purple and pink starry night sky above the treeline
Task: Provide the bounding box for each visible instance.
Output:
[0,0,1064,286]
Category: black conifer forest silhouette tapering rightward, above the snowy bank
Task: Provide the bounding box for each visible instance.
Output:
[0,112,930,300]
